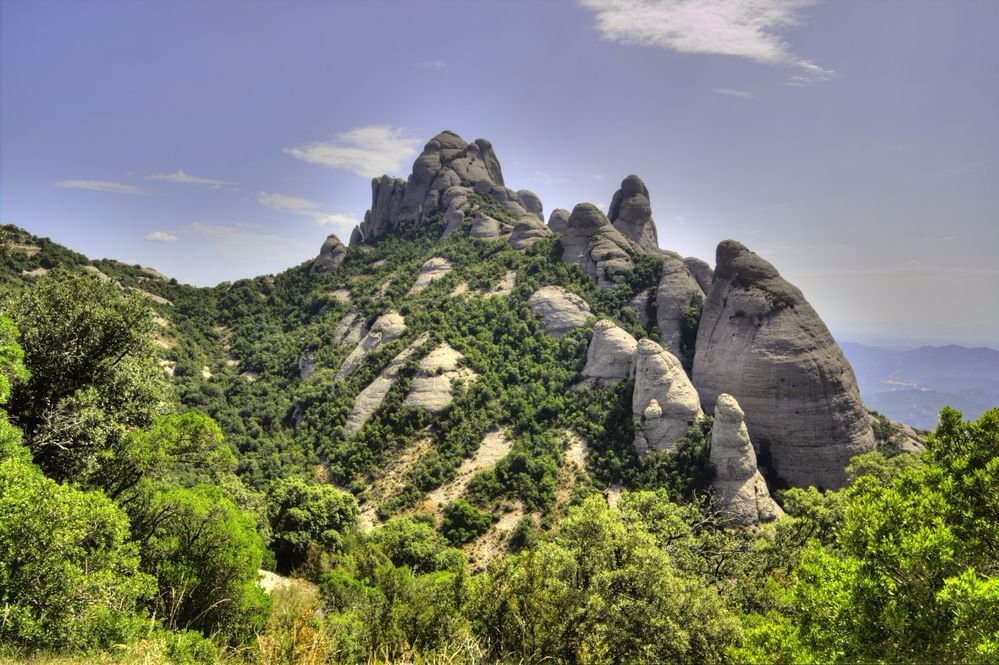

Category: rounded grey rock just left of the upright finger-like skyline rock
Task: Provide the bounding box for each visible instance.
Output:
[561,203,639,288]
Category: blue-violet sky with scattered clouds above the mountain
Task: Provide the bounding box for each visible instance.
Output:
[0,0,999,347]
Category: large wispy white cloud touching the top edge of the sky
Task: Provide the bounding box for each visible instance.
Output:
[579,0,833,85]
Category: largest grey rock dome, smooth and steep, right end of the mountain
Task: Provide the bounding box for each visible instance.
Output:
[693,240,874,488]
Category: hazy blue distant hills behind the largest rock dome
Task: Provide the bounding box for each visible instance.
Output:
[841,342,999,429]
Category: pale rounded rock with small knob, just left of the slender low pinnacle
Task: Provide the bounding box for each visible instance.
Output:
[631,339,704,453]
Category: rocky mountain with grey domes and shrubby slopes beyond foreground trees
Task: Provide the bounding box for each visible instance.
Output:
[0,132,892,544]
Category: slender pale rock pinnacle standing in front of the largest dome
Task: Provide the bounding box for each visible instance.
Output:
[709,393,784,526]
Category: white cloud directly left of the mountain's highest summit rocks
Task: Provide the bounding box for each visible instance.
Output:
[284,125,420,178]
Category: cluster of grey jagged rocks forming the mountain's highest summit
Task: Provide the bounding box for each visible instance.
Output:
[350,131,542,245]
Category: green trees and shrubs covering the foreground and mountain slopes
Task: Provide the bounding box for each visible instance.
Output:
[0,224,999,664]
